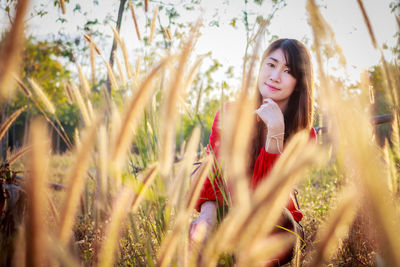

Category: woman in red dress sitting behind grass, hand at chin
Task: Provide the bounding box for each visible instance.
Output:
[190,39,316,264]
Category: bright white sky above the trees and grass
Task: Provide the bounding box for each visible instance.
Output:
[0,0,397,86]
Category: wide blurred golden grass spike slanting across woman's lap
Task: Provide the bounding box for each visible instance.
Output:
[203,133,324,265]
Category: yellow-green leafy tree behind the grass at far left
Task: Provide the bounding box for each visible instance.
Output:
[9,37,79,152]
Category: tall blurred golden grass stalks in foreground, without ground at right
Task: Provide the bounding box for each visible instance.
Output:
[0,0,400,266]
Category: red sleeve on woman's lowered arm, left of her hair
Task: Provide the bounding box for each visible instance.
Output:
[195,110,225,211]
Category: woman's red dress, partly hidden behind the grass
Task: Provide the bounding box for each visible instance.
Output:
[196,110,317,222]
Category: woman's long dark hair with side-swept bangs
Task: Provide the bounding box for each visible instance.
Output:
[249,39,313,174]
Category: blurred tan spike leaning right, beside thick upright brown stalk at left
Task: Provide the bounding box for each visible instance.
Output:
[58,118,98,246]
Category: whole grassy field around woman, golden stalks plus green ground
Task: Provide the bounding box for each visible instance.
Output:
[0,0,400,266]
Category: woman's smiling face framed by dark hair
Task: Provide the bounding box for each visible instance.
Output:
[258,48,296,110]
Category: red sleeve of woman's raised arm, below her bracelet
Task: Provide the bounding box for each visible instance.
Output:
[251,128,317,222]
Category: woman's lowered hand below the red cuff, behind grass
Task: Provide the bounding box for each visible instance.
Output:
[189,201,217,246]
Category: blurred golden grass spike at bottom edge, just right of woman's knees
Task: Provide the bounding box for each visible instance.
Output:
[309,186,358,267]
